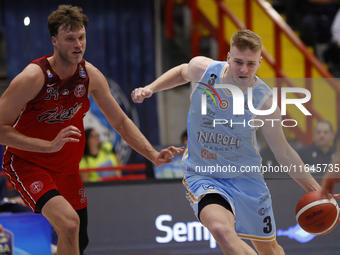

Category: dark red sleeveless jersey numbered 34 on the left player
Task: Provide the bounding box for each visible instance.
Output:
[8,56,90,175]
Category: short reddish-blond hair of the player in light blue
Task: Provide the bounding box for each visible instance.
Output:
[230,30,262,52]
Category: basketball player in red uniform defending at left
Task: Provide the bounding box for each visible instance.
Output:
[0,5,183,255]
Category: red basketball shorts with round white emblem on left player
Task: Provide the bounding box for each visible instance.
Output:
[3,152,87,213]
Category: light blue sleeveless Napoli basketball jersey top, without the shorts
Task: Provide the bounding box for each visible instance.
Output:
[184,61,272,178]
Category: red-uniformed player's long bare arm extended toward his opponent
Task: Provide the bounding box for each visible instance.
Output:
[86,63,183,166]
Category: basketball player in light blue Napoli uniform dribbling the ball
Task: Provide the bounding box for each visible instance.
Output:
[132,30,320,255]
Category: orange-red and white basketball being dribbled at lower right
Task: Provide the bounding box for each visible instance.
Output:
[295,191,339,235]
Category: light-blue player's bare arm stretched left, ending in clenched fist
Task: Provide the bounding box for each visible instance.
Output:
[131,57,212,103]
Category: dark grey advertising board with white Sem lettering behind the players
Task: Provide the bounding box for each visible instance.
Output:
[85,178,340,255]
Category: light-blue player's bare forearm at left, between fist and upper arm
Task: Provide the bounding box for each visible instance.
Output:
[146,64,190,93]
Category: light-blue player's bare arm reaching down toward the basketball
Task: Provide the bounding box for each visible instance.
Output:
[257,98,321,192]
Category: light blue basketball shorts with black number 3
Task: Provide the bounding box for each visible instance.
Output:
[183,170,276,241]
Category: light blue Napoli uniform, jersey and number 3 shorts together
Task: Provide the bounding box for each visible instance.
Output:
[183,61,275,241]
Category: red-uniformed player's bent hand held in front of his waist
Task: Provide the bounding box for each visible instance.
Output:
[48,125,81,152]
